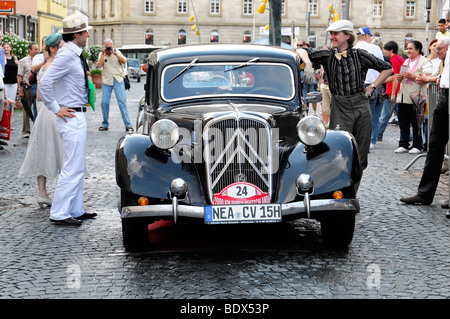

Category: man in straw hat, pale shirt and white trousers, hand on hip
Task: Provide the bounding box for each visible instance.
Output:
[39,14,96,226]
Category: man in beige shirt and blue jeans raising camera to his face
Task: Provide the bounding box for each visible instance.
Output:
[97,39,133,133]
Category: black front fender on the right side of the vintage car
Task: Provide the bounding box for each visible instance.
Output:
[277,131,362,203]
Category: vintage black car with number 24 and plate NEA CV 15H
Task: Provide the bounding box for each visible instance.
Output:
[116,44,361,251]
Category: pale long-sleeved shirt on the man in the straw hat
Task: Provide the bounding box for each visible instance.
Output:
[39,42,88,113]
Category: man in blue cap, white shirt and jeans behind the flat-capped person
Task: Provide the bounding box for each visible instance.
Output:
[354,27,384,149]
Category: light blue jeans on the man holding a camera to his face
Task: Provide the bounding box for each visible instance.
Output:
[102,79,133,128]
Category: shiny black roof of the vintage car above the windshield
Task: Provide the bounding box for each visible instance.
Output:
[149,43,297,64]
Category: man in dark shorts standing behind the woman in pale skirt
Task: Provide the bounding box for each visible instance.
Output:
[17,42,39,138]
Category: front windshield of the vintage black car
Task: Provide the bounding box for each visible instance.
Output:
[161,62,295,102]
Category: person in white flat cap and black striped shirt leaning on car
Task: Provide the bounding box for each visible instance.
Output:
[296,20,393,188]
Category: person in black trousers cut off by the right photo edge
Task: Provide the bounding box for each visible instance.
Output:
[400,10,450,218]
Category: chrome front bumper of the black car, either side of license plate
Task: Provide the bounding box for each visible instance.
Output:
[121,198,359,222]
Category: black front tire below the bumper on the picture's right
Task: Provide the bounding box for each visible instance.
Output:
[320,212,356,249]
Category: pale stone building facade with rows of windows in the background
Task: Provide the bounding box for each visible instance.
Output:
[89,0,448,52]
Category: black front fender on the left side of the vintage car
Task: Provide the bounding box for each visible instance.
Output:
[116,134,205,206]
